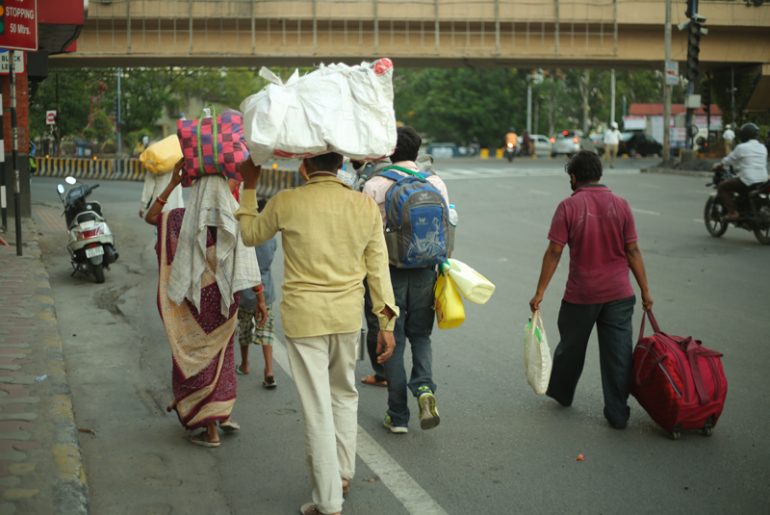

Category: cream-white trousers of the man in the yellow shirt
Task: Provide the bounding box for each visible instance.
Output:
[286,331,360,513]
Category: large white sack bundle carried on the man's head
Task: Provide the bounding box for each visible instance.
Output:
[241,58,396,163]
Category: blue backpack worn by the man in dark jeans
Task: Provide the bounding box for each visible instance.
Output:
[378,166,451,268]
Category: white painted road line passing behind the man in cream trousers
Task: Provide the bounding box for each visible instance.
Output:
[273,338,448,515]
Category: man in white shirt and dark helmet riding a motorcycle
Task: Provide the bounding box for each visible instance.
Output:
[715,123,767,221]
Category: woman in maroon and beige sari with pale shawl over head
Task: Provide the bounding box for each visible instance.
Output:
[145,160,267,447]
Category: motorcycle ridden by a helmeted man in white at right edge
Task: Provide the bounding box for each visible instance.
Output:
[703,165,770,245]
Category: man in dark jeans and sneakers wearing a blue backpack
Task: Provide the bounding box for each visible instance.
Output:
[364,127,449,434]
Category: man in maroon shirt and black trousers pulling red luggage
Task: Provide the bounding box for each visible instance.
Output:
[529,151,652,429]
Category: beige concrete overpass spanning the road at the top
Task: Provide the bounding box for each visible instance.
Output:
[51,0,770,69]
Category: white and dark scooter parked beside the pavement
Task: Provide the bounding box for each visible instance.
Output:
[56,177,118,283]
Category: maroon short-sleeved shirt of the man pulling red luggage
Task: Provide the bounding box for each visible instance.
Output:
[548,184,637,304]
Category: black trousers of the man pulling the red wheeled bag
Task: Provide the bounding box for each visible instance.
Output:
[547,296,636,426]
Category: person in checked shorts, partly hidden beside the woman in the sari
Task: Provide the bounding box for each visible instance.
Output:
[236,199,278,389]
